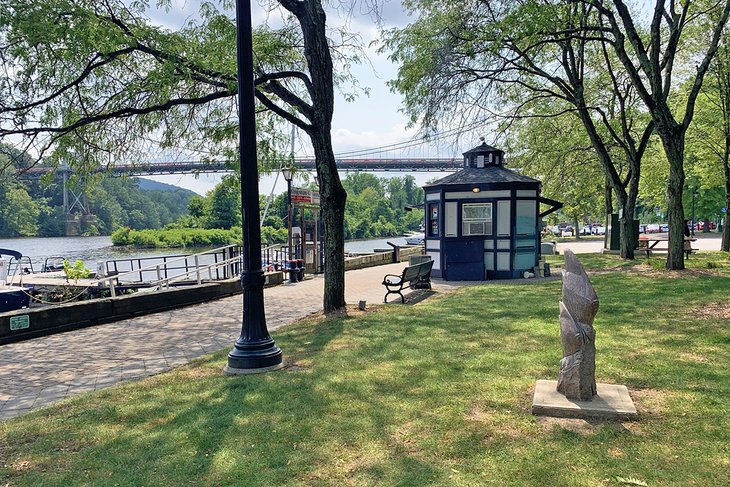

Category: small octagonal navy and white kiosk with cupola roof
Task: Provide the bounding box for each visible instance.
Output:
[424,143,562,281]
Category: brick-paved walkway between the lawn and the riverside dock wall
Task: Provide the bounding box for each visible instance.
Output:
[0,263,467,419]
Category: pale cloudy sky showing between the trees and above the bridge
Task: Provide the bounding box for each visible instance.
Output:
[139,0,456,195]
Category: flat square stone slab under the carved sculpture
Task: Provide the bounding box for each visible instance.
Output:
[532,380,638,419]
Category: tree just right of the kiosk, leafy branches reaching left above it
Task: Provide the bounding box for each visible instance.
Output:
[386,0,653,258]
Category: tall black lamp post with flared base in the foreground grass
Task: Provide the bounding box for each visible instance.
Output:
[223,0,284,375]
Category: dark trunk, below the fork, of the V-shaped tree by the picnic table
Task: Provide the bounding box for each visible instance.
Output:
[657,124,684,270]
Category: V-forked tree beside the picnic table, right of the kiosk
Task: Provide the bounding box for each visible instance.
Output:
[576,0,730,269]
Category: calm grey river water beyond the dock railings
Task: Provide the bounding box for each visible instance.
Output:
[0,237,406,271]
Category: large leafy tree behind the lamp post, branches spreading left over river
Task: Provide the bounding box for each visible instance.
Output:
[0,0,366,311]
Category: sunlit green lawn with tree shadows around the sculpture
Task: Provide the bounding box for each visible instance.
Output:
[0,252,730,487]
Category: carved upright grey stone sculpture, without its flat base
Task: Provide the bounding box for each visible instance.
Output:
[557,250,598,401]
